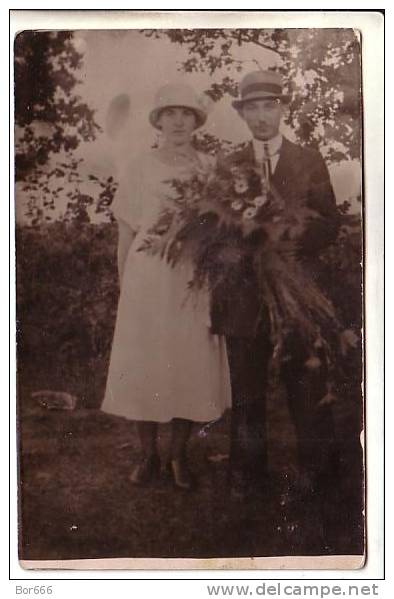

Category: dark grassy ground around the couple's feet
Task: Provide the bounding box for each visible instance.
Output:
[19,388,363,560]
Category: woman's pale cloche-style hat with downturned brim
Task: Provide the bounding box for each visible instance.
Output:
[149,83,207,129]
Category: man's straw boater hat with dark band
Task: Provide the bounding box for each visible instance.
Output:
[232,71,290,110]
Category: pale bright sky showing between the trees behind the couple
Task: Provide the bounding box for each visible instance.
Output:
[17,30,360,224]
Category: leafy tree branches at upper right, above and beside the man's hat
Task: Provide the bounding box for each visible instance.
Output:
[144,29,361,162]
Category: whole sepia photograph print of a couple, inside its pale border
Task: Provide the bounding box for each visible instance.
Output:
[14,18,367,568]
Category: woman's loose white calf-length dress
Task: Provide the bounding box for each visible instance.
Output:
[102,151,231,422]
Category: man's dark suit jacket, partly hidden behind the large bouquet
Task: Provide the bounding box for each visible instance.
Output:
[211,137,338,337]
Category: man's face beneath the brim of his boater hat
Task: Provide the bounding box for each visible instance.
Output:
[239,98,283,141]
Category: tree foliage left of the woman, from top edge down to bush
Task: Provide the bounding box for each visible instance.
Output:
[14,31,116,226]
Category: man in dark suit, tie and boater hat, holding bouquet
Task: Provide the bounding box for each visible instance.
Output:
[212,71,337,496]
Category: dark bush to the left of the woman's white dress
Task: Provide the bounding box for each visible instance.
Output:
[16,221,118,407]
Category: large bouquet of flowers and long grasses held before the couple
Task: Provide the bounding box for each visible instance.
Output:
[141,150,348,384]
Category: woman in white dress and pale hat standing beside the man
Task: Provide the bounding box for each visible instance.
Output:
[102,85,231,489]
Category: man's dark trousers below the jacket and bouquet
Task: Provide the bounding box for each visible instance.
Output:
[227,328,335,492]
